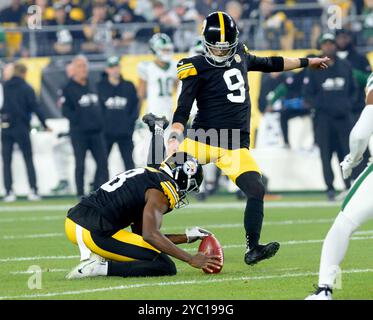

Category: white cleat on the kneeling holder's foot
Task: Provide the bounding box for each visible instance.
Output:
[66,253,107,280]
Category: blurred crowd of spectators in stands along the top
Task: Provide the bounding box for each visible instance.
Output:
[0,0,373,57]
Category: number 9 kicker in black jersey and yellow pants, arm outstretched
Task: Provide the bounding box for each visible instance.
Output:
[168,11,329,265]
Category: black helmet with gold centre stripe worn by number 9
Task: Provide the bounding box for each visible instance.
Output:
[202,11,239,67]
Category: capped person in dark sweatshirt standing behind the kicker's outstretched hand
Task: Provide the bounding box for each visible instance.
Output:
[303,33,355,201]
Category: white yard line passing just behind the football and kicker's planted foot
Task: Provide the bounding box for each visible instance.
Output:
[0,236,373,262]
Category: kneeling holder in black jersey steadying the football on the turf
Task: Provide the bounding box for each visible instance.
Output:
[65,152,221,279]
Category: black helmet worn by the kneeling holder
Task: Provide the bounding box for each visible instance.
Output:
[159,152,203,208]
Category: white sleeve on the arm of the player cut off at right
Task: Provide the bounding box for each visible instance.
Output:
[350,105,373,161]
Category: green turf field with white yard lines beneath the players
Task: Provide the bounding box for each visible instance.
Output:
[0,196,373,300]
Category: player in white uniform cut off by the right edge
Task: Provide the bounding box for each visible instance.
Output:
[306,74,373,300]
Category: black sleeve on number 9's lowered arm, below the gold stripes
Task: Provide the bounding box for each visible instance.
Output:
[172,76,198,126]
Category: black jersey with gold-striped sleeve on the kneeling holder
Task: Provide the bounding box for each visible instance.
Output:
[68,168,179,235]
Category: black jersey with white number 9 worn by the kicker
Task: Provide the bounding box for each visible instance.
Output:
[173,43,284,147]
